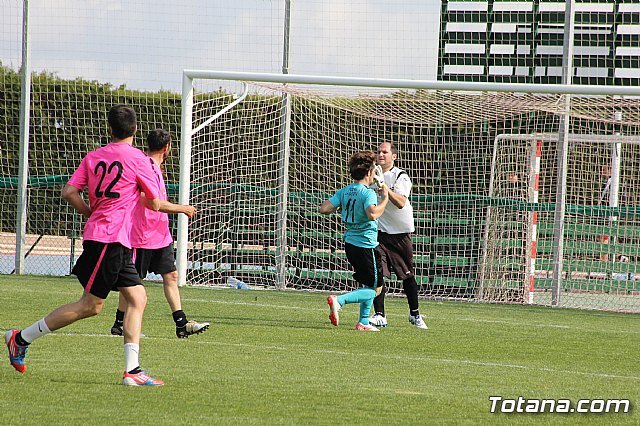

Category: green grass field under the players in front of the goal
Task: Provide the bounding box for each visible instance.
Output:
[0,276,640,425]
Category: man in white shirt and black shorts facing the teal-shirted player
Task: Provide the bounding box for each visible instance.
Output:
[369,142,428,330]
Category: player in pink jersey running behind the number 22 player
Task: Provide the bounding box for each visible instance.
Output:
[111,129,209,338]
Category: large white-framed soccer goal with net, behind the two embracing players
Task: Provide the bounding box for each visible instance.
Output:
[177,70,640,311]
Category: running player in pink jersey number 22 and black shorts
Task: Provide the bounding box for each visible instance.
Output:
[4,105,164,386]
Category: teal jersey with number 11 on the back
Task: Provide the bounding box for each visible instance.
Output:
[329,183,378,248]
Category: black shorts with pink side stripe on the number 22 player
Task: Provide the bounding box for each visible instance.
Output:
[71,240,142,299]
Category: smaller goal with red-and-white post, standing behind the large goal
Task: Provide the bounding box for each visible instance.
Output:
[479,131,640,310]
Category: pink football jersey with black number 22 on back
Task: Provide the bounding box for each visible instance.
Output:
[69,142,160,248]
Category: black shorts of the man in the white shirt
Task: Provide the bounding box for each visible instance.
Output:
[378,231,415,280]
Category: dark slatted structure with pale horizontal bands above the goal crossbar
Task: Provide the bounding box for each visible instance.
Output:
[438,0,640,86]
